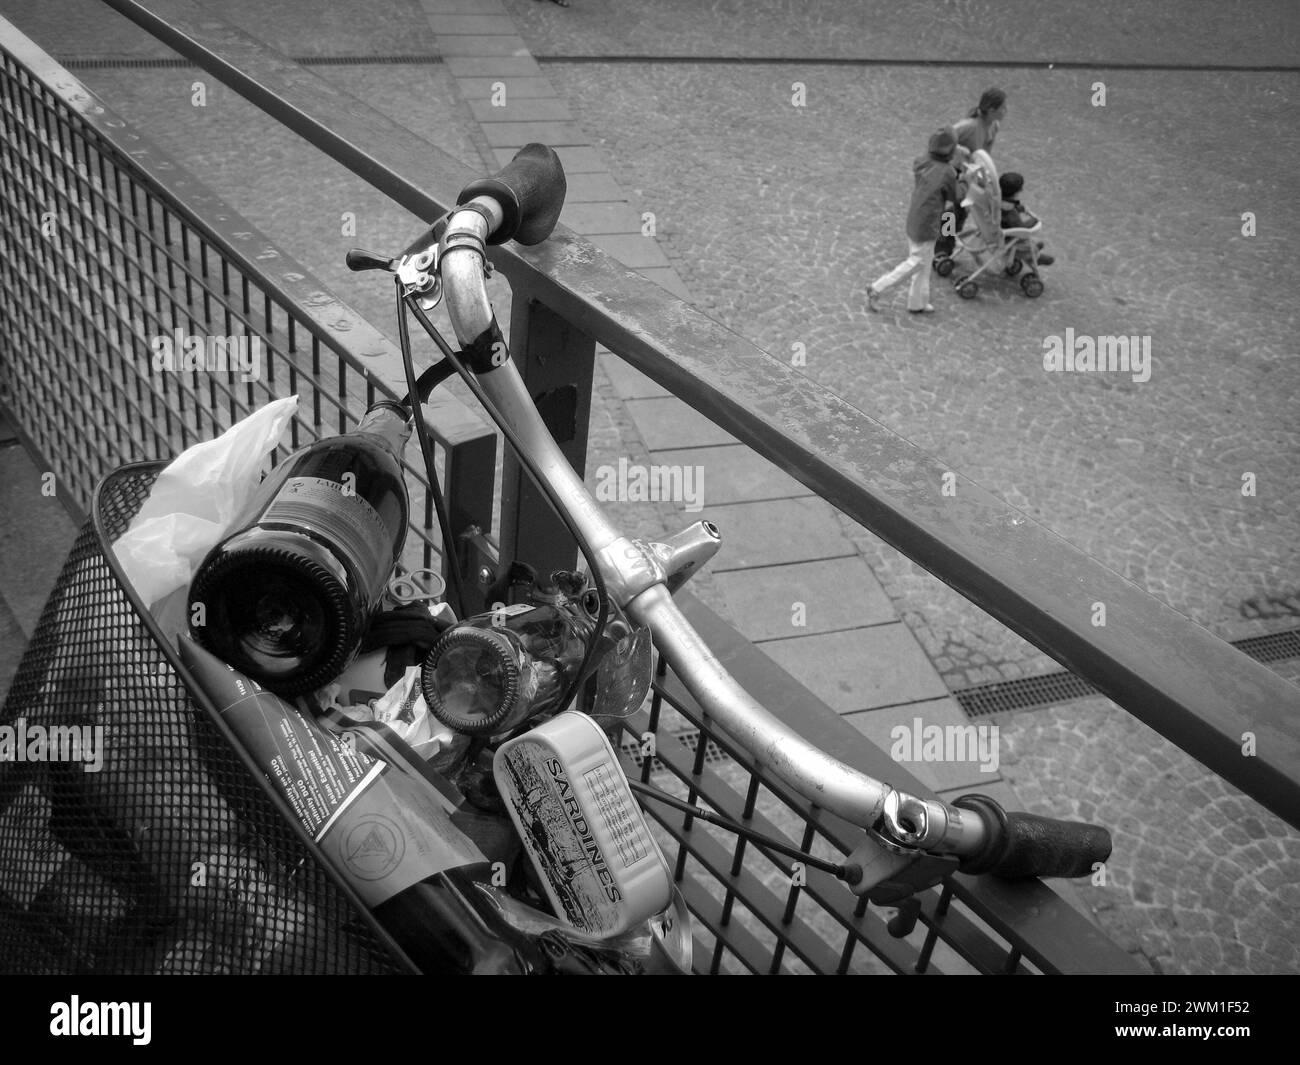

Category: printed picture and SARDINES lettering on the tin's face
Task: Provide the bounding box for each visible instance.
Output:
[498,741,626,935]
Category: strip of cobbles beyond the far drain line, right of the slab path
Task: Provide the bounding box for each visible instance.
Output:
[507,0,1300,66]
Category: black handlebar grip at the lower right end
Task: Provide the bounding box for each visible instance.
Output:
[953,795,1110,880]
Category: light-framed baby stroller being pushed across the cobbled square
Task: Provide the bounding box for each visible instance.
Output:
[935,151,1043,299]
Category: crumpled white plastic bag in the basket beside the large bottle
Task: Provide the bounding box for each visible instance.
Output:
[113,395,298,607]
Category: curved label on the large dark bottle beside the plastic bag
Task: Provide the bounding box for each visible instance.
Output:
[257,477,393,588]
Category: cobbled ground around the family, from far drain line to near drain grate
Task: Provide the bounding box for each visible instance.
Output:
[549,64,1300,687]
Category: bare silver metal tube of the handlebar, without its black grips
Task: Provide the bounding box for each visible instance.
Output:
[438,204,987,856]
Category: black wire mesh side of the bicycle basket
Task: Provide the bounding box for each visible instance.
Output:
[0,463,410,974]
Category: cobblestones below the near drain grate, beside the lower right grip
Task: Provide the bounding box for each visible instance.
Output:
[1000,698,1300,974]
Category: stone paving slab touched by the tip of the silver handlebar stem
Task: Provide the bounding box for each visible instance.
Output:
[696,495,857,574]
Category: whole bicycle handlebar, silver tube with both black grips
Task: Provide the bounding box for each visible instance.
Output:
[410,144,1110,893]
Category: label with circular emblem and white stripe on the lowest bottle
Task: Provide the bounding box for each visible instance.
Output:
[181,637,484,908]
